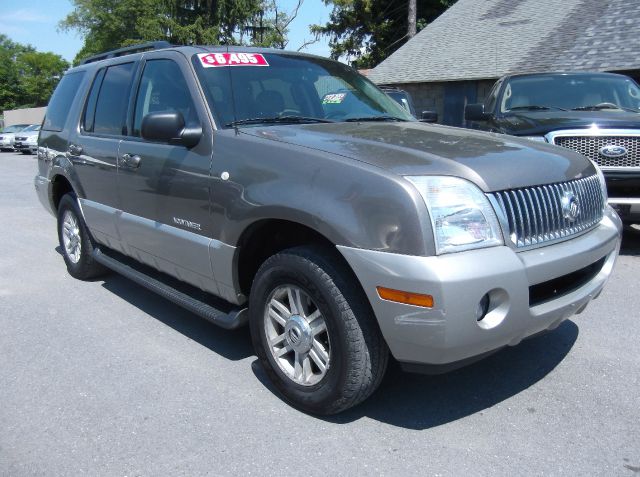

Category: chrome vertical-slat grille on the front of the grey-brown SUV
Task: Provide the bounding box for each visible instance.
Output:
[490,175,604,248]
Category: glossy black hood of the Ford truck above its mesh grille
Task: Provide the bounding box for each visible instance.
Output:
[496,111,640,136]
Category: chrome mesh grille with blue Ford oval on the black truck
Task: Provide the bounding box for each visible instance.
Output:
[553,135,640,168]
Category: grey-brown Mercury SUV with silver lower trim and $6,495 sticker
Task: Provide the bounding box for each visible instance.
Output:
[35,44,621,414]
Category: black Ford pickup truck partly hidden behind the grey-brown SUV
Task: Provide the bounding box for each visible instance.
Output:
[465,73,640,223]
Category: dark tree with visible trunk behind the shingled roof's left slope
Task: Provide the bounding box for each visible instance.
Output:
[311,0,456,68]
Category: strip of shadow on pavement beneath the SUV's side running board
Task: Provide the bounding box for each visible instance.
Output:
[99,273,254,361]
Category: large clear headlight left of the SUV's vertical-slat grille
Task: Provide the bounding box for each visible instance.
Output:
[407,176,504,255]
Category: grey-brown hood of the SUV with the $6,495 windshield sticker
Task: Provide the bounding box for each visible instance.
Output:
[241,121,595,192]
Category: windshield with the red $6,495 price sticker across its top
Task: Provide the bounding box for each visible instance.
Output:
[193,52,414,128]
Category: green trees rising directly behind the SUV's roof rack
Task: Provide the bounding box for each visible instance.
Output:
[59,0,301,62]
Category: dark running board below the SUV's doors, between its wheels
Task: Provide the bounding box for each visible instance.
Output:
[93,248,249,330]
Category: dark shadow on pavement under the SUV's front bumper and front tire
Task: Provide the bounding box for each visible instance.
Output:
[252,321,579,430]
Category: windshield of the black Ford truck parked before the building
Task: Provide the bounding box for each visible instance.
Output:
[500,75,640,113]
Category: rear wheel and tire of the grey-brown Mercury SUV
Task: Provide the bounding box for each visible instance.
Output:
[58,194,107,280]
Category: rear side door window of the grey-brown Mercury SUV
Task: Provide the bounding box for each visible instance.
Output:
[91,63,134,136]
